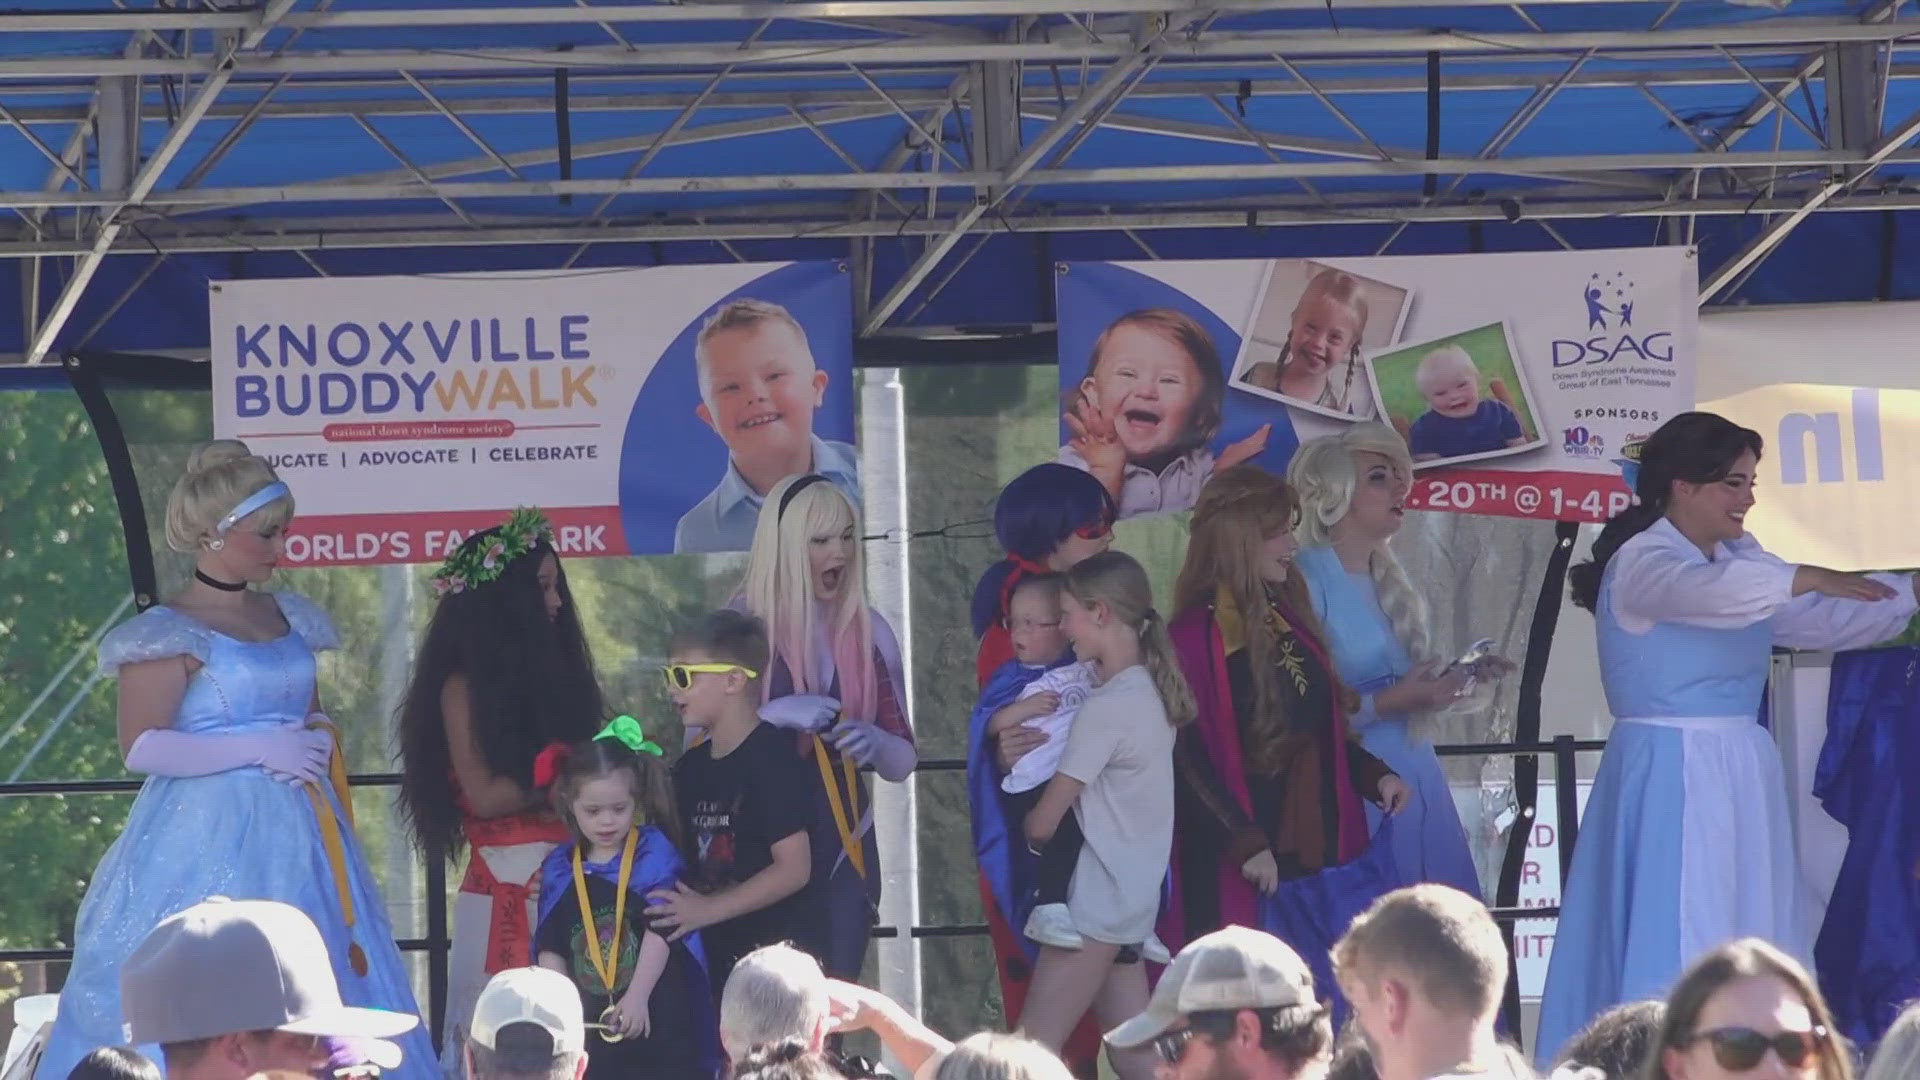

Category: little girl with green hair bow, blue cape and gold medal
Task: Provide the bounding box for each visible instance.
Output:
[534,717,720,1080]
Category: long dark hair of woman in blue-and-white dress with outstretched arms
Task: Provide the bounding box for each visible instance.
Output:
[1567,413,1764,611]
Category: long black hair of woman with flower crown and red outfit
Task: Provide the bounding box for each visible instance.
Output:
[399,528,607,859]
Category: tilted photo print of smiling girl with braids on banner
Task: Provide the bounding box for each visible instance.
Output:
[1233,259,1411,421]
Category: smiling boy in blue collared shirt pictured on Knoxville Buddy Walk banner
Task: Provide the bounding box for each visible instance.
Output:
[674,298,860,553]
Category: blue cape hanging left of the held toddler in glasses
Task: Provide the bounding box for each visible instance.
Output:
[966,653,1073,961]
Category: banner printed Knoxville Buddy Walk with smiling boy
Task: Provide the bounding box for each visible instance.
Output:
[211,261,858,565]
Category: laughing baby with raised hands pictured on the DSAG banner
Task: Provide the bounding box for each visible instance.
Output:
[1060,307,1273,519]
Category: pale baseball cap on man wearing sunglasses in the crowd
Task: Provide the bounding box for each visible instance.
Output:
[1106,926,1319,1049]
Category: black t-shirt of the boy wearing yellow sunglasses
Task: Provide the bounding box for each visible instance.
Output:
[674,723,822,980]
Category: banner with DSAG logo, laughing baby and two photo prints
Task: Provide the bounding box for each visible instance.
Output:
[1056,248,1697,521]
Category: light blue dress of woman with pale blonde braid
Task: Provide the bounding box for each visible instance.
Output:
[1294,548,1480,897]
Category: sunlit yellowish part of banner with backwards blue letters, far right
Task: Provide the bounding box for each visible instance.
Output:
[1701,380,1920,571]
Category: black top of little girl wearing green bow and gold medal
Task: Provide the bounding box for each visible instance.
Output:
[534,874,707,1080]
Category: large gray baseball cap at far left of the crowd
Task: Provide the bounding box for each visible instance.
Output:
[121,897,420,1045]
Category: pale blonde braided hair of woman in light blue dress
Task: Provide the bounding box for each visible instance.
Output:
[1286,421,1434,663]
